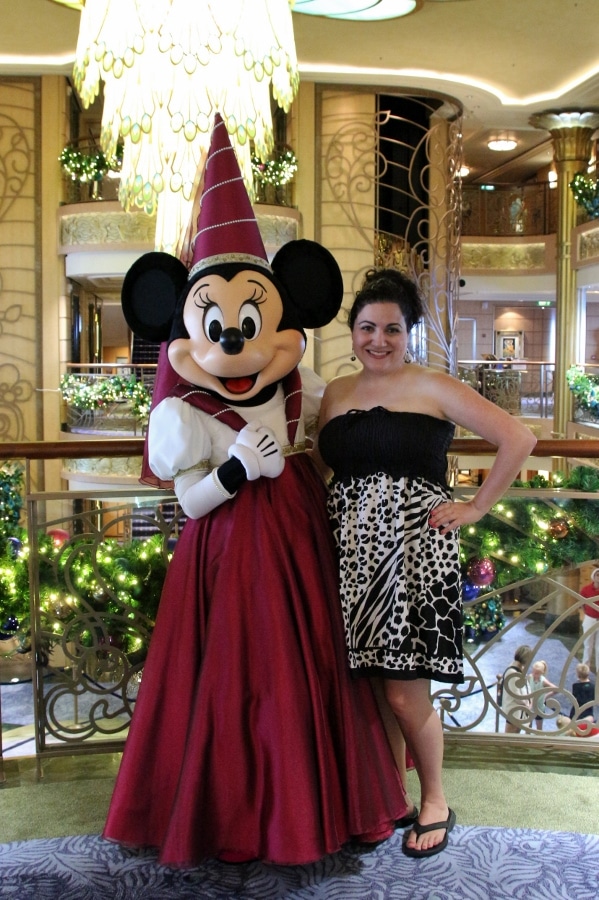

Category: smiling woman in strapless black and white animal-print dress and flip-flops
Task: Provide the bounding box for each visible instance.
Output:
[316,270,535,856]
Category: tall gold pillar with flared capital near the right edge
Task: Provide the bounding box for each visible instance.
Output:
[530,110,599,437]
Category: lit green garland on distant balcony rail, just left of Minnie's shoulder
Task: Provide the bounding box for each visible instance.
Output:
[60,374,152,421]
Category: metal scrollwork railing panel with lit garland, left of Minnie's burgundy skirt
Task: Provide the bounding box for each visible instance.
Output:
[28,489,181,755]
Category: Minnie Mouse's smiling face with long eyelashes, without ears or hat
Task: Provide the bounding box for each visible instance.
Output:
[168,269,305,402]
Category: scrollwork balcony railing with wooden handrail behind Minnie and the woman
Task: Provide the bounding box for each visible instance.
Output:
[0,438,599,780]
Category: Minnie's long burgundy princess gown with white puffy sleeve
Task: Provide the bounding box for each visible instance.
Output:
[104,370,406,866]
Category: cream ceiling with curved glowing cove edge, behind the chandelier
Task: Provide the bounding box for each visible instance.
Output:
[0,0,599,182]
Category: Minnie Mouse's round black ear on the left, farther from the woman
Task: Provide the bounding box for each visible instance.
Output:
[121,252,188,343]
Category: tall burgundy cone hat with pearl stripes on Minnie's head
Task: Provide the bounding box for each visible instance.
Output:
[189,113,272,279]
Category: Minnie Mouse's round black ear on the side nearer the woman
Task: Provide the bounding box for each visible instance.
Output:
[272,239,343,328]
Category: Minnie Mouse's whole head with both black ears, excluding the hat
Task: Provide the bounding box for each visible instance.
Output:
[122,239,343,403]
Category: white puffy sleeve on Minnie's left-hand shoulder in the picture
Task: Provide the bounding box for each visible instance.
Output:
[148,397,212,481]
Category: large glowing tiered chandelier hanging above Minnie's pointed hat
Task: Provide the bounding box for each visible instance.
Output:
[73,0,299,254]
